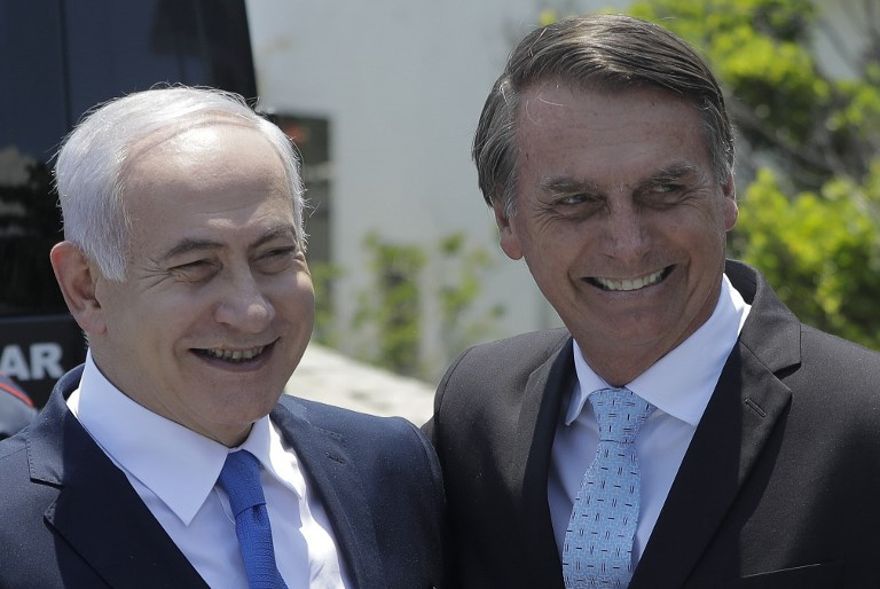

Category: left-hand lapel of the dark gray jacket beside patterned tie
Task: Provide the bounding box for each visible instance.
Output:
[508,337,574,589]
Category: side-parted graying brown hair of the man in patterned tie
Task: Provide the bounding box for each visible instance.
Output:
[473,15,734,217]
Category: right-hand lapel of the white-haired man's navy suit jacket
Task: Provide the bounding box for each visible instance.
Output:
[272,397,387,587]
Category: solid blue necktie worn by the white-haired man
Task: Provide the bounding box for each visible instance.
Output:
[217,450,287,589]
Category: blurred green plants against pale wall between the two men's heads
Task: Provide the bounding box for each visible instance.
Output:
[320,232,504,376]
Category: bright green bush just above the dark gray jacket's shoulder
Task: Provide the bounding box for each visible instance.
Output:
[736,160,880,348]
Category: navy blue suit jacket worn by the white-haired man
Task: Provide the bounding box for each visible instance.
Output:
[0,367,443,589]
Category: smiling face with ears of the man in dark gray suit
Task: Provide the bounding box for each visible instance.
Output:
[495,82,737,385]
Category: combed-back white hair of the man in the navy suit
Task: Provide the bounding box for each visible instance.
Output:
[55,86,306,281]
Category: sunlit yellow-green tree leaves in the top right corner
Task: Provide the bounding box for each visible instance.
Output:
[630,0,880,190]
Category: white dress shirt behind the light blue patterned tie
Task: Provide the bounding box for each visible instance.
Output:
[547,276,751,562]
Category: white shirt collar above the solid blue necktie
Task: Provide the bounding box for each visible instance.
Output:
[68,353,289,525]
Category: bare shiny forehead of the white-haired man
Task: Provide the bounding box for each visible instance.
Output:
[125,125,296,254]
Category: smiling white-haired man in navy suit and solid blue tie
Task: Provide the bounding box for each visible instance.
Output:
[0,87,443,589]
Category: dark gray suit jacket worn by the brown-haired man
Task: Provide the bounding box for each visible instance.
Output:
[425,262,880,589]
